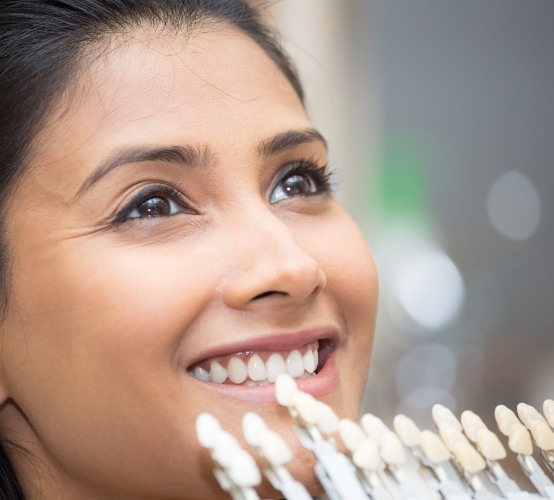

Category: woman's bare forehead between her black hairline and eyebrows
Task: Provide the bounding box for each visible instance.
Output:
[31,24,308,177]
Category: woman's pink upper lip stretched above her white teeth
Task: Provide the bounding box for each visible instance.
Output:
[184,327,339,366]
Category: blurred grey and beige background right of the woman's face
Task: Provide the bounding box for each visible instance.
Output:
[261,0,554,426]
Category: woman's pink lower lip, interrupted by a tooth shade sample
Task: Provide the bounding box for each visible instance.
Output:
[196,352,338,403]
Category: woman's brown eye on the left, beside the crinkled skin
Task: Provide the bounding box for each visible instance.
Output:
[115,186,195,224]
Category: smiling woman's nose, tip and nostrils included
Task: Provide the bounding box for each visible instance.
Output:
[219,208,326,309]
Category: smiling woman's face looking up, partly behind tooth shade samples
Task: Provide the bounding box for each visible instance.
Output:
[0,27,377,499]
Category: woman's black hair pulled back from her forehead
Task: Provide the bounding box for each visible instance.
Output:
[0,0,303,500]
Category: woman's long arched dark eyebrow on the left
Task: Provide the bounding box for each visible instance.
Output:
[76,146,213,196]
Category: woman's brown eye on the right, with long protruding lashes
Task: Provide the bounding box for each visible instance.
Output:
[269,162,331,203]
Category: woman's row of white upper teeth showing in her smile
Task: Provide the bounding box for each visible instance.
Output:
[189,342,318,385]
